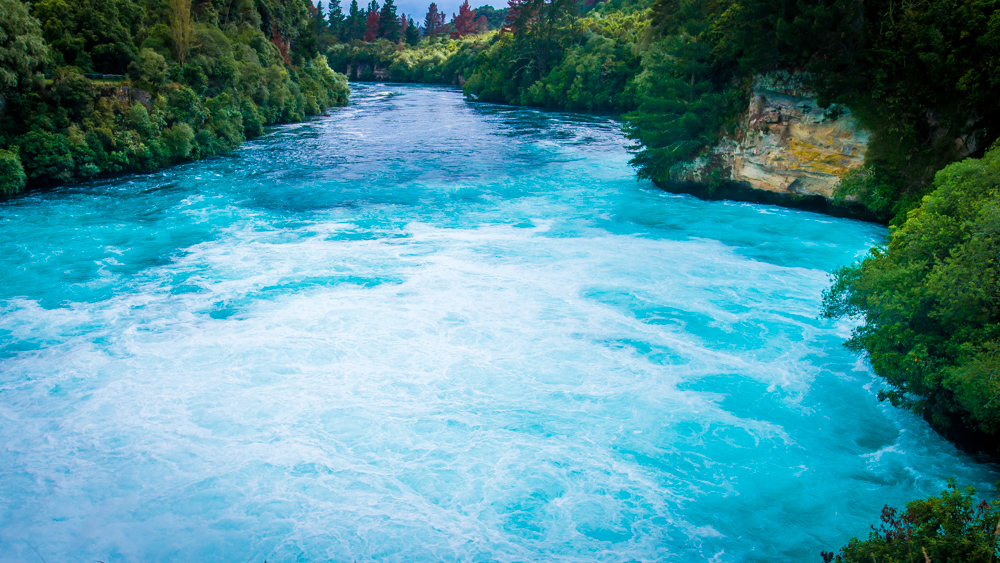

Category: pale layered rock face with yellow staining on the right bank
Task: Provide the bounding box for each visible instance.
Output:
[671,72,869,205]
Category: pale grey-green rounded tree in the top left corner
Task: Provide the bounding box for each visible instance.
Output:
[0,0,48,96]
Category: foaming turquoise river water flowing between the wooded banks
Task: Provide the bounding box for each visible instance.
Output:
[0,85,998,563]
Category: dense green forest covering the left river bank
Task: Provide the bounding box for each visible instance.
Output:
[0,0,348,194]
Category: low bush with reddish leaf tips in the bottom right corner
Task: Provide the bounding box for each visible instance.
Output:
[822,482,1000,563]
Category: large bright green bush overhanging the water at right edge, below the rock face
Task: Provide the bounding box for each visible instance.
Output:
[824,147,1000,450]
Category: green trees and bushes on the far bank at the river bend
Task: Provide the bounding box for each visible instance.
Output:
[329,3,647,115]
